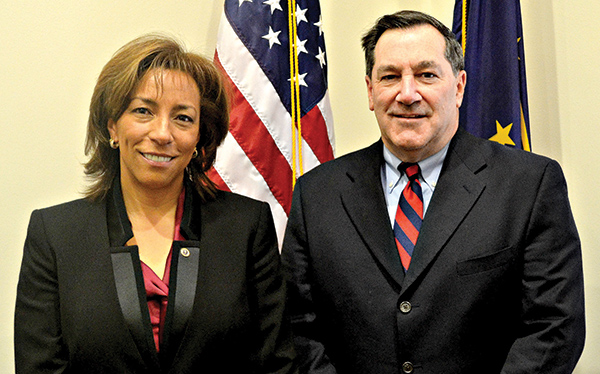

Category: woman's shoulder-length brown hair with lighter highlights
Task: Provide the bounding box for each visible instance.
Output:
[84,34,229,201]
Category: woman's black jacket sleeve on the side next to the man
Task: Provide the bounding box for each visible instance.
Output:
[252,203,297,373]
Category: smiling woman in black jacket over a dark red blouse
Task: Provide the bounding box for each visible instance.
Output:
[15,36,294,373]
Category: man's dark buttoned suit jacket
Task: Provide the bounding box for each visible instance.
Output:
[282,129,585,374]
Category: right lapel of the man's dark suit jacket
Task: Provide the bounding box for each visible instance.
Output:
[402,129,486,291]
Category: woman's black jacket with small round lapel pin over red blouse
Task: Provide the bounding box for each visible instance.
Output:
[15,183,294,374]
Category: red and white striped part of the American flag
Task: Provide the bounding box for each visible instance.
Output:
[210,14,334,248]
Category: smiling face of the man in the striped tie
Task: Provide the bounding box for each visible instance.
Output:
[366,25,466,162]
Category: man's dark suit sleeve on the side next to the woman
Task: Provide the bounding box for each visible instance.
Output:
[282,179,336,374]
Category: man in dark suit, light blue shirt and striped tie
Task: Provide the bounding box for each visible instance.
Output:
[282,11,585,374]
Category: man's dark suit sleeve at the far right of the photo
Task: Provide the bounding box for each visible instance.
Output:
[502,161,585,374]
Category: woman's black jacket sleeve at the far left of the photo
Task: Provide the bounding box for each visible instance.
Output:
[14,211,68,374]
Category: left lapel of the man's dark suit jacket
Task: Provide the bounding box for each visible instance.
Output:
[341,141,404,286]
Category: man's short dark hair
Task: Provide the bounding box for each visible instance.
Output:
[362,10,465,76]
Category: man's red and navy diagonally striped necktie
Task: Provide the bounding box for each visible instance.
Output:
[394,162,423,271]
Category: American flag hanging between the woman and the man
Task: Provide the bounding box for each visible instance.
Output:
[210,0,334,246]
